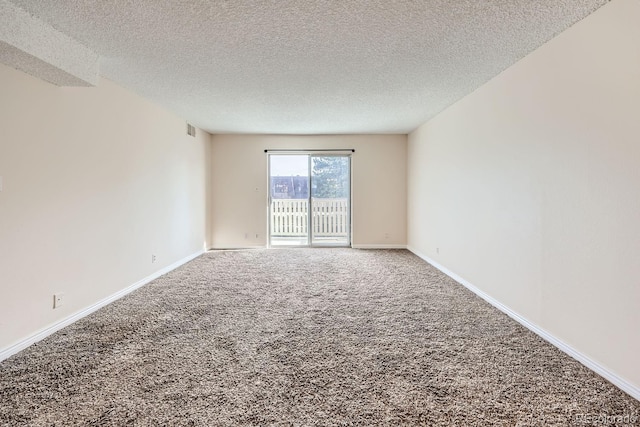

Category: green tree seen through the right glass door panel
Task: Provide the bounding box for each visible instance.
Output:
[311,156,349,199]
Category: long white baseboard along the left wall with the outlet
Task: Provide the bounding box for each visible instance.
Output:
[0,251,204,361]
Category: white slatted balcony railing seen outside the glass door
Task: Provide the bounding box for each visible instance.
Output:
[270,198,349,238]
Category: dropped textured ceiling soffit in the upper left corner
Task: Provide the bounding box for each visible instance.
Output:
[0,0,98,86]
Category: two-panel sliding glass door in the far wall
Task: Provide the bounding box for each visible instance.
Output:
[269,154,351,247]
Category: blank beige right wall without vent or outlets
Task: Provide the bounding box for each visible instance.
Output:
[408,0,640,388]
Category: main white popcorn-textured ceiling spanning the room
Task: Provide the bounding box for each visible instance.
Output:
[5,0,608,134]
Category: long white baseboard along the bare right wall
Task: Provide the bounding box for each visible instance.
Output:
[407,246,640,400]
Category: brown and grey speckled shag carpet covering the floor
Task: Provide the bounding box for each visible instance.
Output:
[0,249,640,426]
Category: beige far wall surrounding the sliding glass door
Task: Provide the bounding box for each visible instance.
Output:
[212,135,407,248]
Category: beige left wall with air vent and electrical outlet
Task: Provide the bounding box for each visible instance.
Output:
[0,65,211,350]
